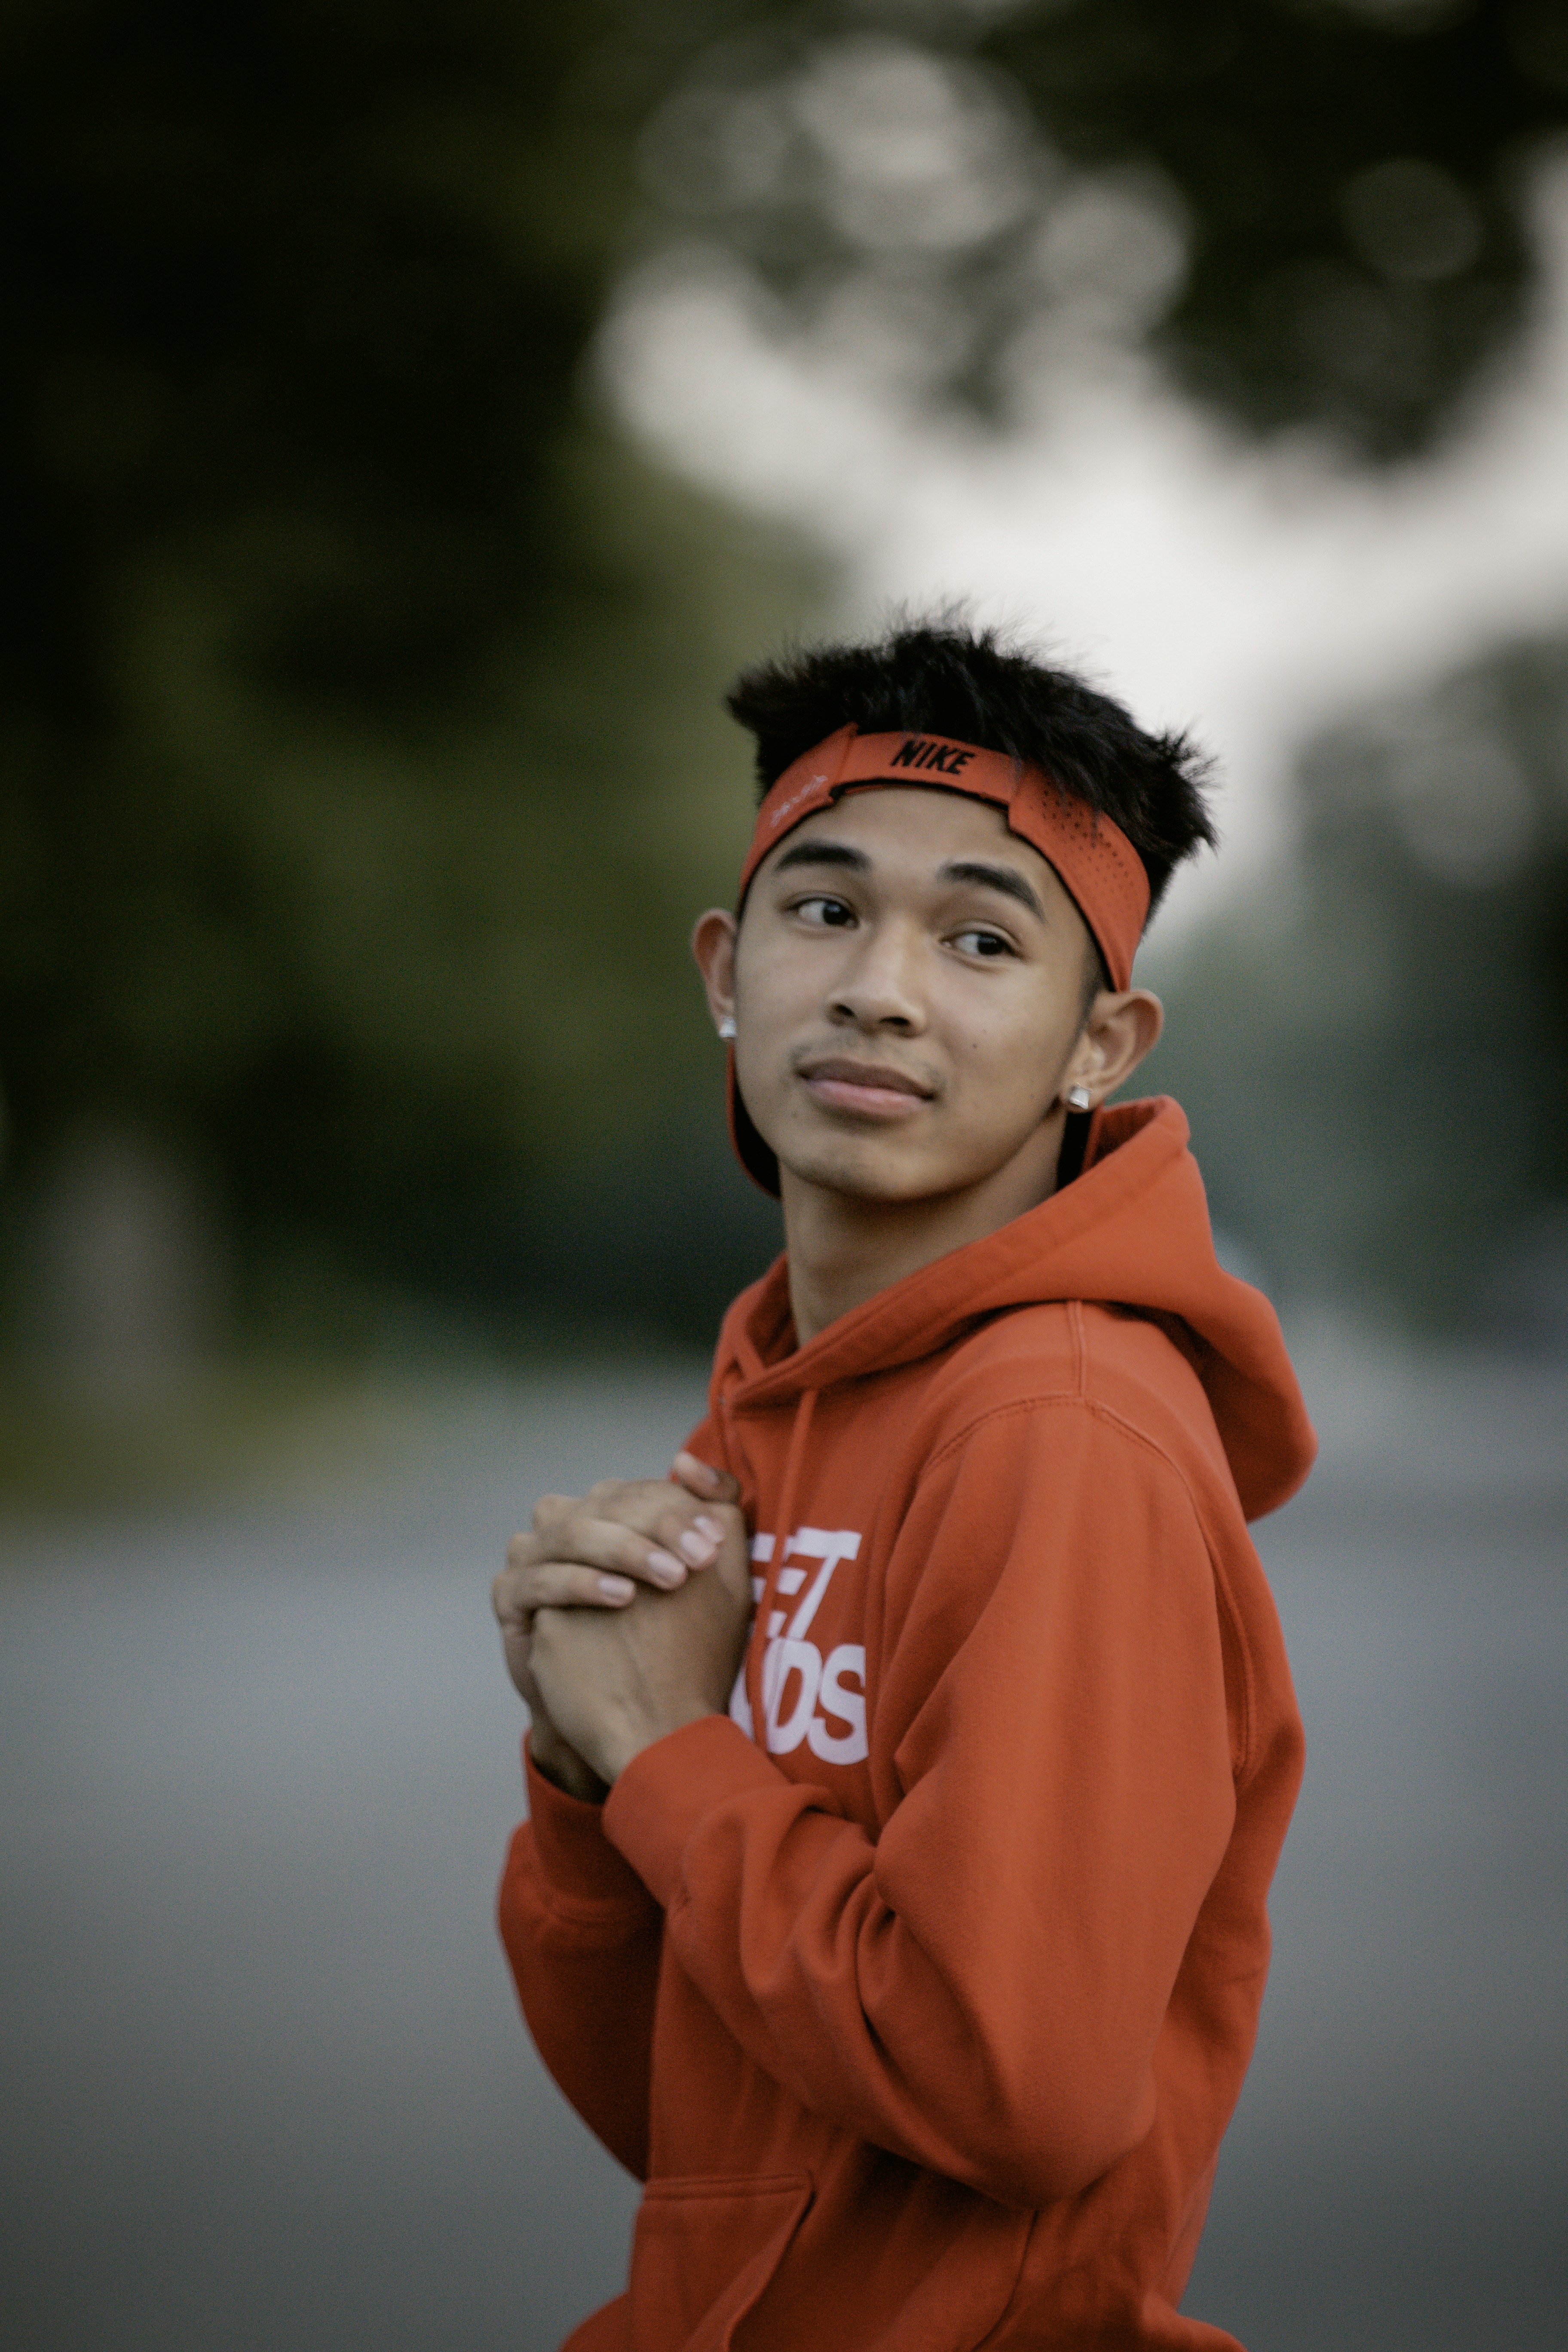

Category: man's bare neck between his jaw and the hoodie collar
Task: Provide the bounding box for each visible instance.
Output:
[781,1112,1063,1348]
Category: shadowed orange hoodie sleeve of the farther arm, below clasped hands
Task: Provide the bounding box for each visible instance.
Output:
[498,1743,663,2180]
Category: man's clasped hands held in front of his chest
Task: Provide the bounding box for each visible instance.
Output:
[491,1454,752,1802]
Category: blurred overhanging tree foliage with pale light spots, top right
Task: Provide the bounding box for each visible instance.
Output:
[642,0,1568,459]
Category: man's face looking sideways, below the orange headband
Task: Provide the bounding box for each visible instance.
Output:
[733,786,1091,1202]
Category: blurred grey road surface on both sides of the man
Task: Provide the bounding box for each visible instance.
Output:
[0,1362,1568,2352]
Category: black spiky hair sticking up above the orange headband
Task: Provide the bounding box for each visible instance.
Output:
[724,609,1218,913]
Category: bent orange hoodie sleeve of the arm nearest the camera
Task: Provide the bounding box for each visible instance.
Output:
[604,1400,1234,2206]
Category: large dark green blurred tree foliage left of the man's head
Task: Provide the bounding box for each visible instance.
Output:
[0,0,816,1334]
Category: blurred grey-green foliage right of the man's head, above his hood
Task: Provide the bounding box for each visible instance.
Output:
[1152,640,1568,1343]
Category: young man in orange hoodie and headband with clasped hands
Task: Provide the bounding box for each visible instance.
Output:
[496,623,1312,2352]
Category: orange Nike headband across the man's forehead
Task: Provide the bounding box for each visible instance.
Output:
[741,727,1149,988]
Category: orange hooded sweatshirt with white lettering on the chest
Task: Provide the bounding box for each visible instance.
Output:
[501,1101,1314,2352]
